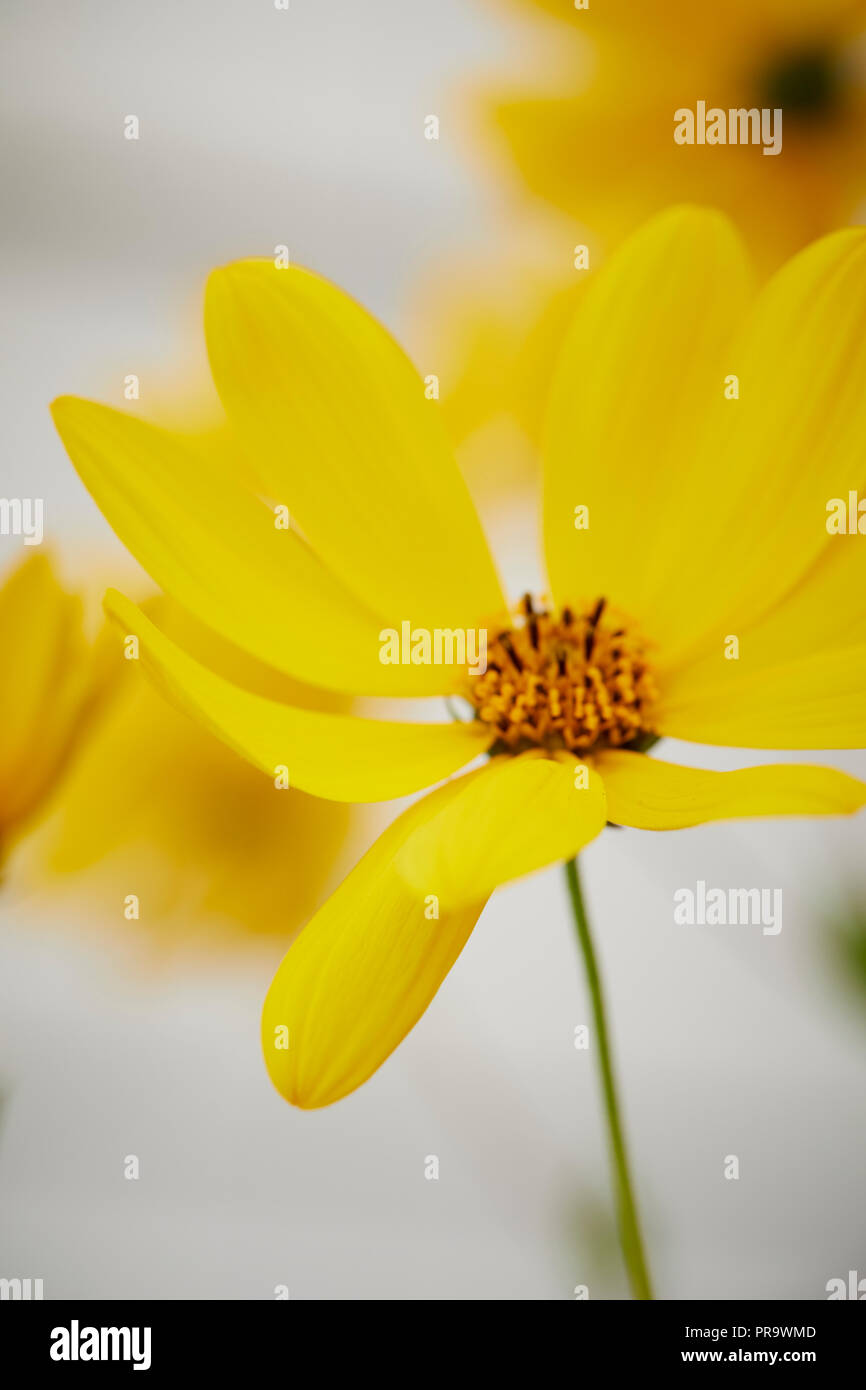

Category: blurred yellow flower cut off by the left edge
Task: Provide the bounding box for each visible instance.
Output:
[0,550,100,866]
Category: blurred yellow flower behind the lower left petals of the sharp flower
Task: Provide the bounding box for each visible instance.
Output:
[27,599,352,951]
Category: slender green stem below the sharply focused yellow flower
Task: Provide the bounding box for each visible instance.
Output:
[566,859,652,1298]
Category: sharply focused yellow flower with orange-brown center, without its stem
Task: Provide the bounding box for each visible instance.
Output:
[54,210,866,1108]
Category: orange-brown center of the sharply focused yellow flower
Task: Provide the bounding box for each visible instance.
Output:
[470,594,656,752]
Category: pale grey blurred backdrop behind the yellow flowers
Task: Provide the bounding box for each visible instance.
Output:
[0,0,866,1298]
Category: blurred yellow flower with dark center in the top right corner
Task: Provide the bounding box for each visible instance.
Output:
[489,0,866,268]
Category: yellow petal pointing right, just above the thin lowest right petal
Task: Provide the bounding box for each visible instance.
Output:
[655,644,866,748]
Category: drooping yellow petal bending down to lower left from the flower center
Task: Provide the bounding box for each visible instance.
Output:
[261,759,605,1109]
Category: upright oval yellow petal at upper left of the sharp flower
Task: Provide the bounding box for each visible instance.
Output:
[206,261,503,627]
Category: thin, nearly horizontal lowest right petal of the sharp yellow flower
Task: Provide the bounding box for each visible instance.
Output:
[594,749,866,830]
